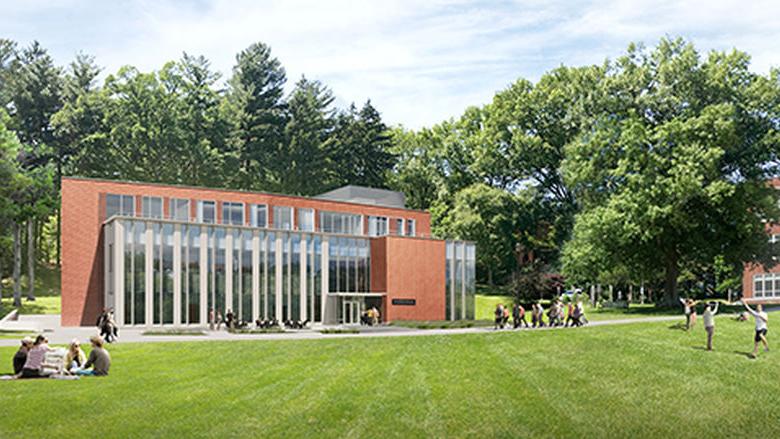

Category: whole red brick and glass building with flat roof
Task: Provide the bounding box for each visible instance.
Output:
[62,177,475,326]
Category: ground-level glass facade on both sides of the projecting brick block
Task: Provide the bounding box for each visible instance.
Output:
[105,218,476,325]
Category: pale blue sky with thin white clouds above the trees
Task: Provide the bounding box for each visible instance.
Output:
[0,0,780,129]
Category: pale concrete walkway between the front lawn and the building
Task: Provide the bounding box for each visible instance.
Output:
[0,315,684,346]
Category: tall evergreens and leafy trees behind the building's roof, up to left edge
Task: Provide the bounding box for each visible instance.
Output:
[0,40,395,301]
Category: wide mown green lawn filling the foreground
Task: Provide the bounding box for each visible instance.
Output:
[0,317,780,438]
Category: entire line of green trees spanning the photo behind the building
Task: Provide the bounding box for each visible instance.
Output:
[0,39,780,306]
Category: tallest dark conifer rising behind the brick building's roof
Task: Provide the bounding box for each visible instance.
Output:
[228,43,287,189]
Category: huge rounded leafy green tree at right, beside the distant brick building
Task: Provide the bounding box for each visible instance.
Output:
[562,39,780,301]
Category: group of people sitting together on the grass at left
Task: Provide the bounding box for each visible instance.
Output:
[11,334,111,378]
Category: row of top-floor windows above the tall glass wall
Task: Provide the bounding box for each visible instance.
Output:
[106,194,417,236]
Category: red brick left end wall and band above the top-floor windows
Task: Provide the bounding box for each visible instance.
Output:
[61,177,432,326]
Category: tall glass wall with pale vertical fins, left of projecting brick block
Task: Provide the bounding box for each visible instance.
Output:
[114,219,370,325]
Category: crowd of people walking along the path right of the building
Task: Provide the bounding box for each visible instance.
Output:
[494,299,588,329]
